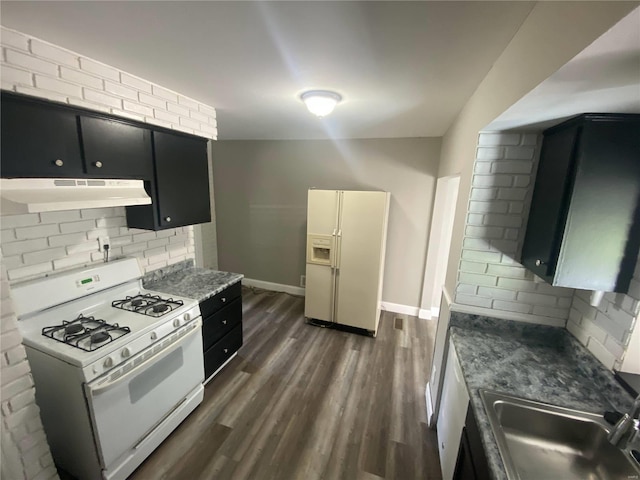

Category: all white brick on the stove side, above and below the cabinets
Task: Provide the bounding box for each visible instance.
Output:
[0,27,217,480]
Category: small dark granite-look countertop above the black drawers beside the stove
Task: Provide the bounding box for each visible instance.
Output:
[142,260,244,302]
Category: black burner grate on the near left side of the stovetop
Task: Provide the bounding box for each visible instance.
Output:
[42,314,131,352]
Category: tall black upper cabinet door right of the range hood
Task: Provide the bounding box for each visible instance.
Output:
[153,131,211,228]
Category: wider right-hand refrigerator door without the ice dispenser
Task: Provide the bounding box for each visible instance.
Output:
[335,191,389,331]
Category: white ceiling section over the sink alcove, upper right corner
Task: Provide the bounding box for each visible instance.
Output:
[486,7,640,131]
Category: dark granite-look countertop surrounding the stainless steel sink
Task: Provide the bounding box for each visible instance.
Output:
[450,312,633,480]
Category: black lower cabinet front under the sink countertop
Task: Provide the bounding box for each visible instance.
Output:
[453,406,491,480]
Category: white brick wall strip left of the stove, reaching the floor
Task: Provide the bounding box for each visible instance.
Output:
[0,258,58,480]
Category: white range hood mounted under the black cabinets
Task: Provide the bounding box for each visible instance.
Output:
[0,178,151,215]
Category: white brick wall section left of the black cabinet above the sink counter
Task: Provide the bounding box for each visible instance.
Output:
[455,132,573,326]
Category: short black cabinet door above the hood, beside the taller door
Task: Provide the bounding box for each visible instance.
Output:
[80,116,153,180]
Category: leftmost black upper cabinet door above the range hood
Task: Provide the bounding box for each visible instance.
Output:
[1,95,84,178]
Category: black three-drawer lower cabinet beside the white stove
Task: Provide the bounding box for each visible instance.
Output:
[200,282,242,381]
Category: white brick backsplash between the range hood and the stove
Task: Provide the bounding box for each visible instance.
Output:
[0,207,195,283]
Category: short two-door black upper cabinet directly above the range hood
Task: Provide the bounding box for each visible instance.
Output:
[0,92,153,180]
